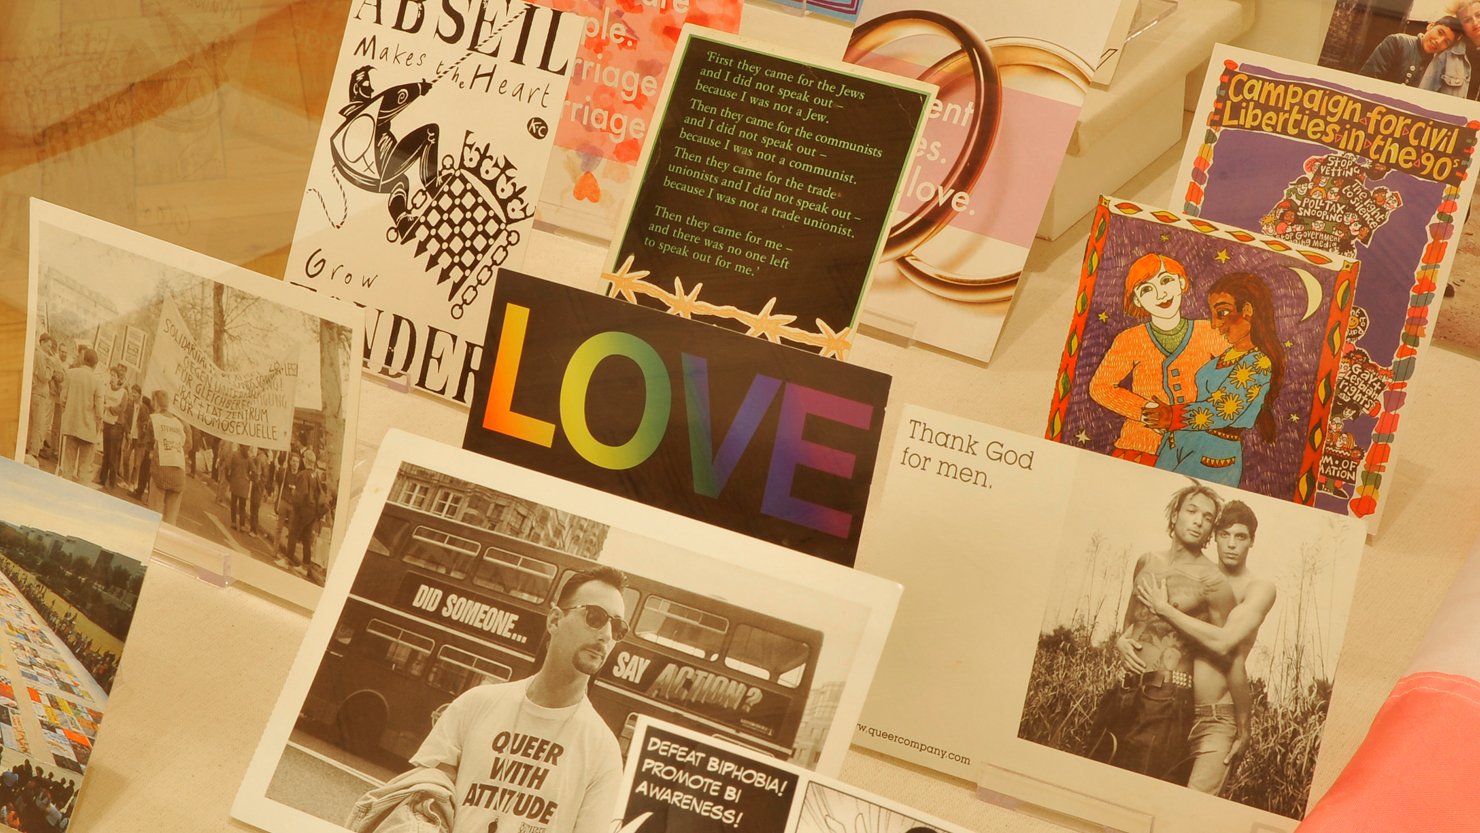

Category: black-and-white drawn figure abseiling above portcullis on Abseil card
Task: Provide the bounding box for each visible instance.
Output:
[329,67,438,241]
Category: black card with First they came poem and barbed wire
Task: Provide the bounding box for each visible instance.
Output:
[604,27,934,358]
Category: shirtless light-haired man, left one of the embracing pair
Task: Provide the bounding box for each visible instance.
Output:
[1091,484,1237,784]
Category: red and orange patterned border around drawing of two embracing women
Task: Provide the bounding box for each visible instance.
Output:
[1046,197,1359,506]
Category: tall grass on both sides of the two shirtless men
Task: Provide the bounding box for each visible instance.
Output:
[1018,624,1331,818]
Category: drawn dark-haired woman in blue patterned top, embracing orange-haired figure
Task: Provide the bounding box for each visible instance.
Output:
[1146,272,1285,485]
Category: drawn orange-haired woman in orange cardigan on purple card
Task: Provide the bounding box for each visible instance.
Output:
[1089,253,1228,466]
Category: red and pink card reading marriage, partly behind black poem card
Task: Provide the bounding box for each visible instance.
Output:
[539,0,743,240]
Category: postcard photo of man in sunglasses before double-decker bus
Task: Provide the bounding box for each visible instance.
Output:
[234,432,898,832]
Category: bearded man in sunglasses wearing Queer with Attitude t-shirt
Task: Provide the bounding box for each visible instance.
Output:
[411,567,628,833]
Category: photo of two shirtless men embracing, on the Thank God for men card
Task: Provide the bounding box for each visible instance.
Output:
[1018,463,1362,820]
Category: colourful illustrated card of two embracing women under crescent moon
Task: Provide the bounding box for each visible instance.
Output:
[1048,197,1359,505]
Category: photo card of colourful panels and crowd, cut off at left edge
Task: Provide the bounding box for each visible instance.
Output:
[0,460,160,833]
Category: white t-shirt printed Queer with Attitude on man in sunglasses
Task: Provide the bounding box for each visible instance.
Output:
[411,679,622,833]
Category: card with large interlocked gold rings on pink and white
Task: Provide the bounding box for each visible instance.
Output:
[845,0,1134,361]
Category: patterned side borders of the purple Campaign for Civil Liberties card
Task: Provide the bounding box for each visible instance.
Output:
[1183,61,1480,518]
